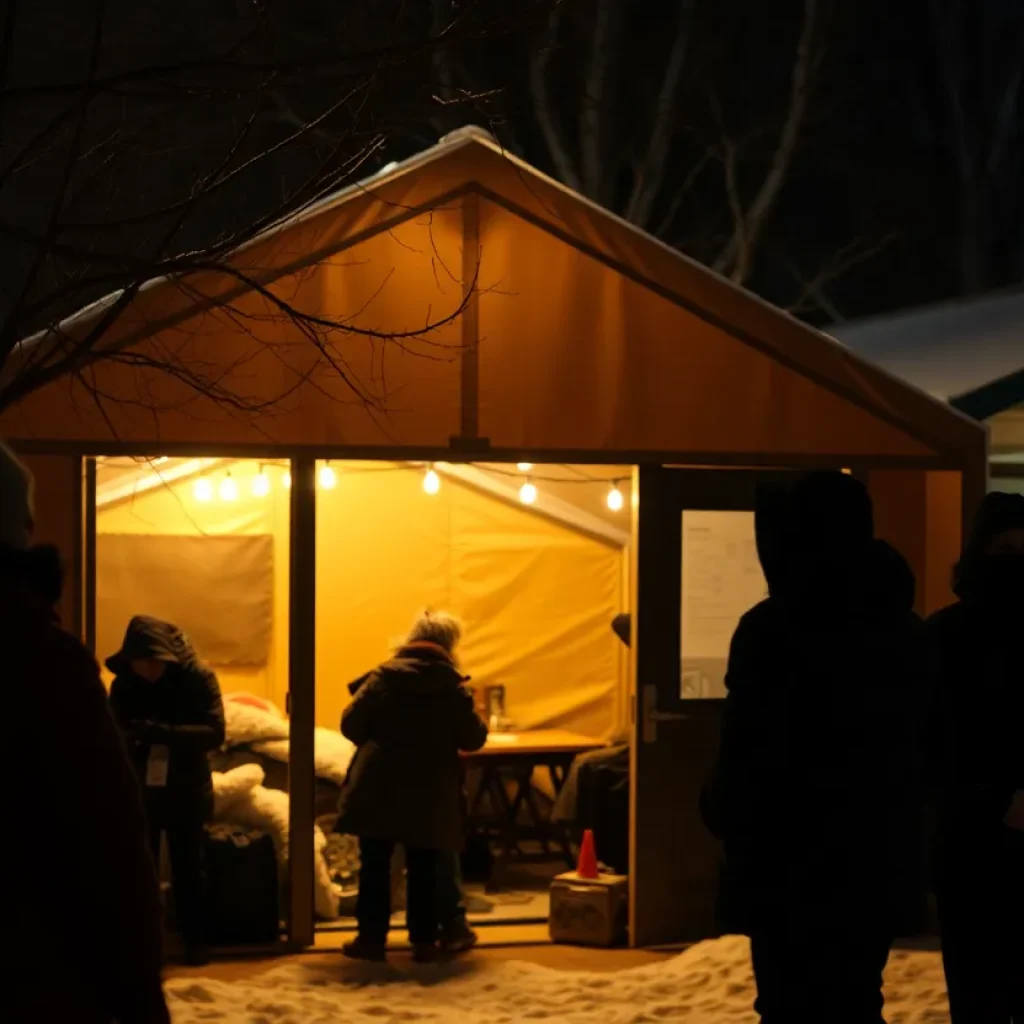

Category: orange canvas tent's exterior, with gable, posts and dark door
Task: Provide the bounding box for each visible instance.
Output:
[0,123,986,943]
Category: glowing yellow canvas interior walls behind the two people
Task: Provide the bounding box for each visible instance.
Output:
[96,459,629,737]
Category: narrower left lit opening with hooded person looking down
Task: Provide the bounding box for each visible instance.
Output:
[94,456,290,949]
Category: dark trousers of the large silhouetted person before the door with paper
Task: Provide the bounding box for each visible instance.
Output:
[751,923,892,1024]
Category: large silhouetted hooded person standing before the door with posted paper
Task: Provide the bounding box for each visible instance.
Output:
[703,473,928,1024]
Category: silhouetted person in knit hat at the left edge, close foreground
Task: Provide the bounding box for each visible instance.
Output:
[0,444,169,1024]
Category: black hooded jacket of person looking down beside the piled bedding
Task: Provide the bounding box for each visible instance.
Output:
[106,615,224,804]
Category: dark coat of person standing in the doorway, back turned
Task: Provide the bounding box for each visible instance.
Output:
[336,643,487,851]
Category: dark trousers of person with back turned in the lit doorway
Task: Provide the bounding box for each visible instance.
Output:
[355,839,443,945]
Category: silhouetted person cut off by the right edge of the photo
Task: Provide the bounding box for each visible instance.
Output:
[928,494,1024,1024]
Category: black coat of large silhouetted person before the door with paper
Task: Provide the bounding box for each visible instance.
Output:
[703,542,929,934]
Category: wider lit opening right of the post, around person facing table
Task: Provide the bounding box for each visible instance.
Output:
[316,461,632,930]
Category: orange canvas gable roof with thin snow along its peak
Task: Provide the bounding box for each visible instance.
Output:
[2,128,984,462]
